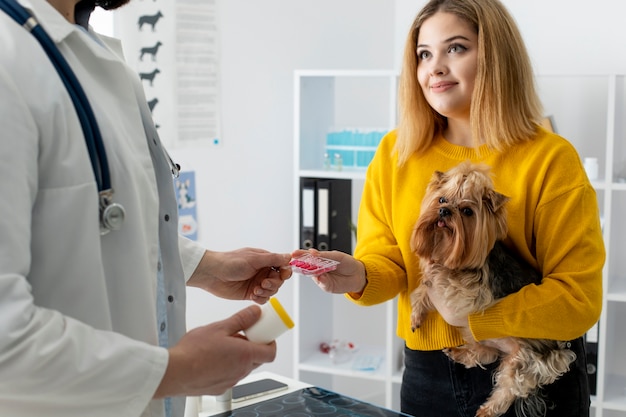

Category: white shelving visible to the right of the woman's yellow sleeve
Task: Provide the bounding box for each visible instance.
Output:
[537,74,626,417]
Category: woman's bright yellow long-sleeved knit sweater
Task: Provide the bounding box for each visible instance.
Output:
[347,129,605,350]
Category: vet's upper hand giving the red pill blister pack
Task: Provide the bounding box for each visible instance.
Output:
[187,248,291,304]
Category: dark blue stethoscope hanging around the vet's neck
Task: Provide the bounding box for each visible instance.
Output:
[0,0,180,235]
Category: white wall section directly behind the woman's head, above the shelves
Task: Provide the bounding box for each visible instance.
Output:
[395,0,626,74]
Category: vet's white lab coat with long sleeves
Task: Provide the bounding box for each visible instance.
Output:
[0,0,203,417]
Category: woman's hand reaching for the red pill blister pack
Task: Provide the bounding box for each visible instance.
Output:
[291,249,367,294]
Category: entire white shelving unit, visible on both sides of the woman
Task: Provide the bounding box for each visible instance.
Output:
[294,70,626,417]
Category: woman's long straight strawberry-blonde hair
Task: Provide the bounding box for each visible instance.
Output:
[395,0,542,165]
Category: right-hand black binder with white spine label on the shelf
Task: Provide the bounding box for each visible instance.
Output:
[316,179,352,253]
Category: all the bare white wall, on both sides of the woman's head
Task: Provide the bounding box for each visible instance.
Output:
[105,0,626,376]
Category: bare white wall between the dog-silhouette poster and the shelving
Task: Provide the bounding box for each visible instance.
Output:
[166,0,394,376]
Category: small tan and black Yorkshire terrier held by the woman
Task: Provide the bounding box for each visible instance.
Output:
[411,162,576,417]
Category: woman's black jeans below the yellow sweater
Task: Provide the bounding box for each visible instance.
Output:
[400,338,590,417]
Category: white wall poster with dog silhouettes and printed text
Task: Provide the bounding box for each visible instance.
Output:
[114,0,222,149]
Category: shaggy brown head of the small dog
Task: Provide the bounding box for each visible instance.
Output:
[411,162,509,269]
